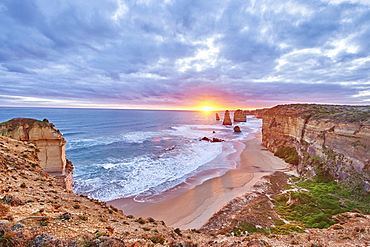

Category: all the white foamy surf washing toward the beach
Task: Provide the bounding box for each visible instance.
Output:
[73,116,261,201]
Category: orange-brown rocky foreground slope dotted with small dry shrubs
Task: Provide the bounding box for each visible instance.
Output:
[0,137,370,246]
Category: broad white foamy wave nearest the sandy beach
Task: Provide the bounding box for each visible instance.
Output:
[75,142,233,201]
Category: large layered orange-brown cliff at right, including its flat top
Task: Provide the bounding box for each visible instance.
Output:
[262,105,370,191]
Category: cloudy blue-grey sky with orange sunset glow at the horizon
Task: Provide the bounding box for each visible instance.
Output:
[0,0,370,109]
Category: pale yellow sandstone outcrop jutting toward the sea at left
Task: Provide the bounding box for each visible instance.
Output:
[0,118,73,190]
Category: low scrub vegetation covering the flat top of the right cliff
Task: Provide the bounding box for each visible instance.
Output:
[265,104,370,125]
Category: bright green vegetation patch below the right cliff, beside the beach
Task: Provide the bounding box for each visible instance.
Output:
[271,178,370,234]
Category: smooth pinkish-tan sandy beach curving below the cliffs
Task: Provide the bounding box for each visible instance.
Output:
[108,133,289,229]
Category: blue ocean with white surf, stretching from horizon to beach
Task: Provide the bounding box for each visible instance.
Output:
[0,107,261,202]
